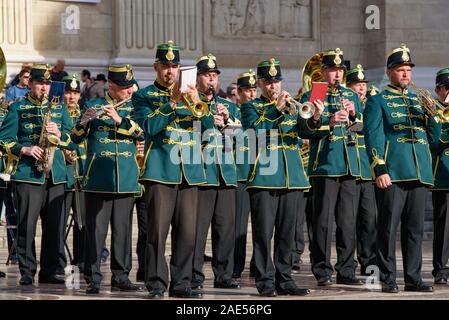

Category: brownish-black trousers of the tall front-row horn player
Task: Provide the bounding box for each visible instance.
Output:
[145,182,198,291]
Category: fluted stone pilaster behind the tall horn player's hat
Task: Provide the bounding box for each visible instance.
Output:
[113,0,203,64]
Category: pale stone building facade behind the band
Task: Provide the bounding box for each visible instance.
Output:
[0,0,449,91]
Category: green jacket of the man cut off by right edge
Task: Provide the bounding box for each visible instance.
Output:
[430,102,449,190]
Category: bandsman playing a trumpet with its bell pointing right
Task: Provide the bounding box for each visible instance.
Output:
[241,59,323,297]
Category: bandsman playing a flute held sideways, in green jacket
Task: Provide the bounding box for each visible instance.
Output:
[72,65,143,294]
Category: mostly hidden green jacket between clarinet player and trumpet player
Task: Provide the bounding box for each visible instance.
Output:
[234,106,250,182]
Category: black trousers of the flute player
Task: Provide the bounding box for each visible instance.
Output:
[84,192,134,284]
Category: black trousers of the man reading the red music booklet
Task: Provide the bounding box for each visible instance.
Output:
[311,176,357,279]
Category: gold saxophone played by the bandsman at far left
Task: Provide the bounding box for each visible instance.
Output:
[36,99,61,174]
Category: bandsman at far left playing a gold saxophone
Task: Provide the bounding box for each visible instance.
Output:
[0,65,73,285]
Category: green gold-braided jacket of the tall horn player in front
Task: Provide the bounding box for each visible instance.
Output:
[133,82,206,185]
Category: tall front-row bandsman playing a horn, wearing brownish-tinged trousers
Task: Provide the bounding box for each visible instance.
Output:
[133,41,206,299]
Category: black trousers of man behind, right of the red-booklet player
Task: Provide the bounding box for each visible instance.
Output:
[356,180,377,271]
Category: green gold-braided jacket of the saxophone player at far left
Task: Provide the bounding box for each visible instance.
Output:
[0,94,73,184]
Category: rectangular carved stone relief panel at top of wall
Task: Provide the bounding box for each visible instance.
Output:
[211,0,312,38]
